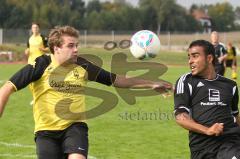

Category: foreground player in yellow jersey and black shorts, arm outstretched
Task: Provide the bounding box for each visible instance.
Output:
[0,26,172,159]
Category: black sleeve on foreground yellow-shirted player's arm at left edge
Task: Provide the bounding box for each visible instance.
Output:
[9,55,50,90]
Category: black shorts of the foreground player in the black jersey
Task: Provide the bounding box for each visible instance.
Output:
[191,136,240,159]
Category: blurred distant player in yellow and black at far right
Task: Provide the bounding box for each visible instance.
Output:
[226,42,237,79]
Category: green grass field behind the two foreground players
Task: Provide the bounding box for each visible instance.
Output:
[0,49,238,159]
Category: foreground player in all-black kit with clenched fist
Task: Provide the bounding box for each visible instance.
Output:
[174,40,240,159]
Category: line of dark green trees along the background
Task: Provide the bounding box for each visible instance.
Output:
[0,0,240,32]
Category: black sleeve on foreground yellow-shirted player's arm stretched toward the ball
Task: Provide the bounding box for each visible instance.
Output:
[77,57,116,86]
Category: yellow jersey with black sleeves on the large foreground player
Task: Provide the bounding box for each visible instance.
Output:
[9,55,116,132]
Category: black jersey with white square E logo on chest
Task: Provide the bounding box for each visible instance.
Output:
[174,73,239,151]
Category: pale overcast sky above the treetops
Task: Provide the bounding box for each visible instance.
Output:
[85,0,240,8]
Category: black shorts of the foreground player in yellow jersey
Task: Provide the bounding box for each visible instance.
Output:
[35,122,88,159]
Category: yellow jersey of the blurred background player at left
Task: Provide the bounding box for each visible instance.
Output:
[27,34,48,63]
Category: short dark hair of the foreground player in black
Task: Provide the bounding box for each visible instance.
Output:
[188,40,216,65]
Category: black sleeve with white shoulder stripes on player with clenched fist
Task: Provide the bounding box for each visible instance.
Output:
[174,74,191,115]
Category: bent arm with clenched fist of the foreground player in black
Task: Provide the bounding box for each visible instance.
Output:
[174,74,223,136]
